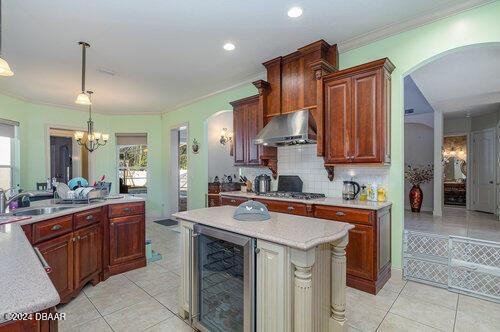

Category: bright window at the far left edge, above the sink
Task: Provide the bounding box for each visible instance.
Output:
[0,119,19,189]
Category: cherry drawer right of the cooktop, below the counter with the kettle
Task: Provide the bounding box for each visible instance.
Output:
[314,205,375,225]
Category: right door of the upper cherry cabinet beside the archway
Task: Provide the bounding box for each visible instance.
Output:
[350,70,385,163]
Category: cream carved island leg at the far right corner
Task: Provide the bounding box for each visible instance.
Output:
[330,235,349,332]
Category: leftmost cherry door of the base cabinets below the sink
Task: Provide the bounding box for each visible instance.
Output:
[37,233,74,299]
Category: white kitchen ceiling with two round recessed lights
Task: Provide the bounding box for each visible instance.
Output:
[0,0,488,114]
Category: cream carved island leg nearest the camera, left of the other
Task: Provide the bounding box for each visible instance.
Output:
[291,249,315,332]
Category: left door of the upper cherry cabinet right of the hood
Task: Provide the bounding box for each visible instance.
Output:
[324,78,352,164]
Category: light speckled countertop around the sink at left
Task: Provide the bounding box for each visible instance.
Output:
[0,196,144,323]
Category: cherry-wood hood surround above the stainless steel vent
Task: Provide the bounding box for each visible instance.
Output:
[254,39,339,156]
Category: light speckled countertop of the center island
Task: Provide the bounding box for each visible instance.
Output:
[173,206,354,250]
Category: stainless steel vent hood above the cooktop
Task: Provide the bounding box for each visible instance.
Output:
[254,110,317,146]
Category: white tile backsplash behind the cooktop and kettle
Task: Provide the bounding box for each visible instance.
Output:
[240,144,390,197]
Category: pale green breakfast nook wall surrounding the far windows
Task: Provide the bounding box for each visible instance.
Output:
[0,94,163,215]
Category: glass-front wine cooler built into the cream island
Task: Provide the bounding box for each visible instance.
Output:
[190,225,256,332]
